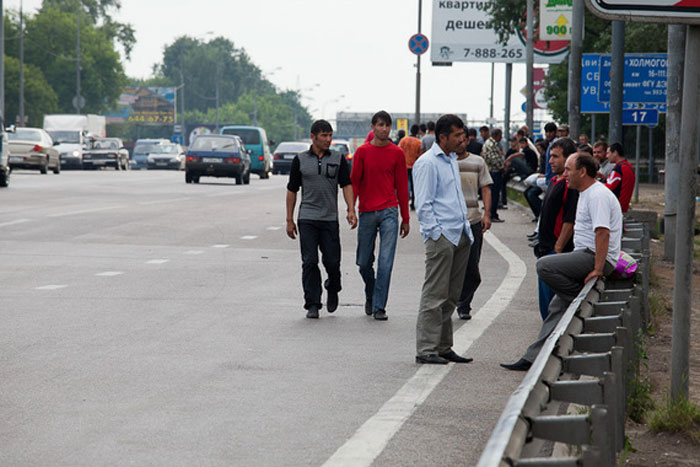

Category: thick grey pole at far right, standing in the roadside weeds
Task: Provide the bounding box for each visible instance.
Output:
[671,26,700,400]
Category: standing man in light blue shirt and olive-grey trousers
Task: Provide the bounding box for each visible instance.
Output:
[413,114,474,365]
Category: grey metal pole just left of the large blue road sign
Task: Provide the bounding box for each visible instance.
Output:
[567,0,584,140]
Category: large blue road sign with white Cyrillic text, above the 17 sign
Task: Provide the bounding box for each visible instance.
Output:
[598,54,667,104]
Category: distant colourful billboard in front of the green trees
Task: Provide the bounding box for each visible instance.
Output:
[106,87,175,125]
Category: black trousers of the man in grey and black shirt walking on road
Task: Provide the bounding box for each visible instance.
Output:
[298,219,341,310]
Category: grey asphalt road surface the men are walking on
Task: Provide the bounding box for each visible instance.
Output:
[0,171,540,466]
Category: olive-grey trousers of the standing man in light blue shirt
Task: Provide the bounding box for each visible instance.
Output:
[416,232,471,356]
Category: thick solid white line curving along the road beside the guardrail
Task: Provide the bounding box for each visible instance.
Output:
[323,233,527,467]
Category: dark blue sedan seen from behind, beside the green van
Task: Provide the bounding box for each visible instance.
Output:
[185,134,251,185]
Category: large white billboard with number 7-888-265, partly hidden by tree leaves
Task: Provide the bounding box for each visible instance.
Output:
[430,0,569,63]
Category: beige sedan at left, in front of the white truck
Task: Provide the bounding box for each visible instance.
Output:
[7,128,61,174]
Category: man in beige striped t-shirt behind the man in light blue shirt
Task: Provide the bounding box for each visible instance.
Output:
[457,128,493,320]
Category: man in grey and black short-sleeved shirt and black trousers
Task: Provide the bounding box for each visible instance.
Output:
[287,120,357,319]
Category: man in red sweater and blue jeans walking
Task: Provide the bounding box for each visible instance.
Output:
[350,110,409,321]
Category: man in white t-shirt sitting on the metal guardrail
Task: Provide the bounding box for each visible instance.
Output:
[501,154,622,371]
